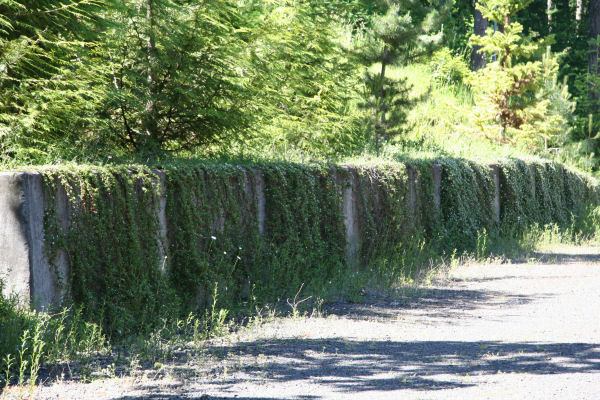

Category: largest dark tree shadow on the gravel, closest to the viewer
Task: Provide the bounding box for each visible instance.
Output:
[119,339,600,400]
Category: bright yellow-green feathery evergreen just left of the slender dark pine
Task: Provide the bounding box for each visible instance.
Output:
[241,0,362,157]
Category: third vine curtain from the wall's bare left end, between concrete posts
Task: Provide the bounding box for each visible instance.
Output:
[260,164,345,295]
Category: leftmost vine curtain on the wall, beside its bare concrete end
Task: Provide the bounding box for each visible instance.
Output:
[44,167,177,335]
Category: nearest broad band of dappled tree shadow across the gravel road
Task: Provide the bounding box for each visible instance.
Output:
[211,339,600,382]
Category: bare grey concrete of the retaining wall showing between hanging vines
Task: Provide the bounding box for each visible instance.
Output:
[0,164,510,309]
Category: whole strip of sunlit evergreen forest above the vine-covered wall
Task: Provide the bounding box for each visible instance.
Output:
[0,0,600,171]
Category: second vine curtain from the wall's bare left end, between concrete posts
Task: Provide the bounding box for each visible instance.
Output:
[166,165,259,310]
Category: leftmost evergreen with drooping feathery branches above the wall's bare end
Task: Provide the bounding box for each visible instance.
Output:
[0,0,110,162]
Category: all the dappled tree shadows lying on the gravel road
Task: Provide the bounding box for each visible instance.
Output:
[47,248,600,400]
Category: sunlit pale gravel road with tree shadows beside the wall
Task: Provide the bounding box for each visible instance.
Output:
[21,248,600,400]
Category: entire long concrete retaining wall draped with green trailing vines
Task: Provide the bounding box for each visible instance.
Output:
[0,159,599,334]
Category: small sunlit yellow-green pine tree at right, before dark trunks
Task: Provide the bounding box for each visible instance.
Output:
[471,0,573,148]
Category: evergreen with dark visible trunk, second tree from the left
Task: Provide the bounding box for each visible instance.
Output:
[94,0,251,153]
